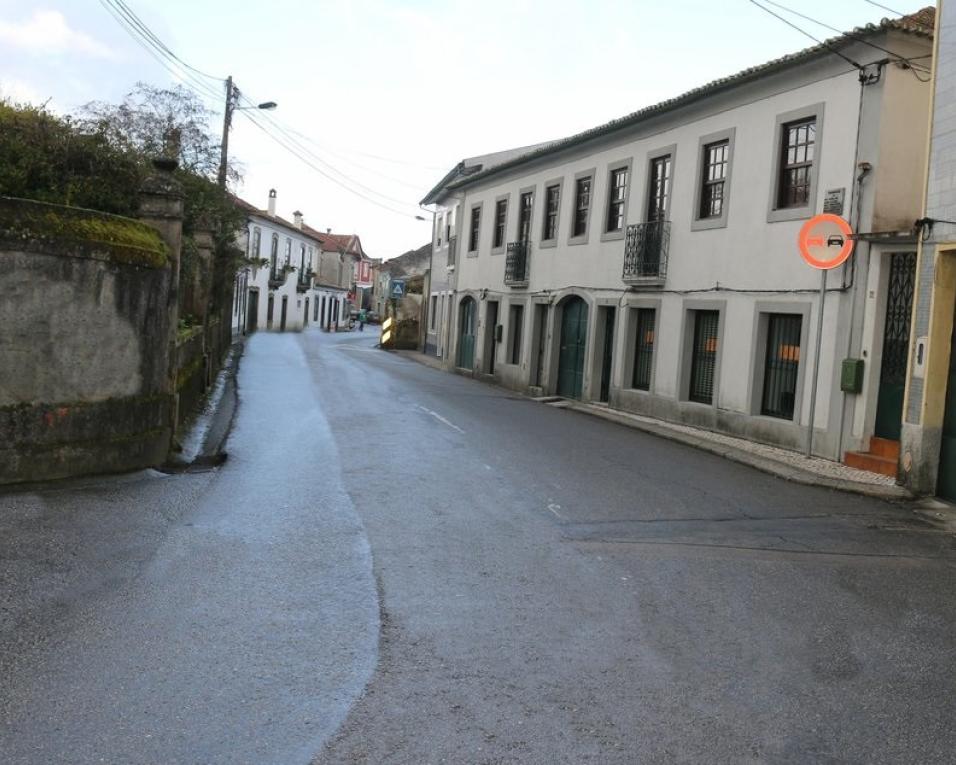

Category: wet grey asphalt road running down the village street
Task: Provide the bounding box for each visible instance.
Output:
[0,331,956,765]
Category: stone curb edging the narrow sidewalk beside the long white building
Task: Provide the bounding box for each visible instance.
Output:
[391,351,917,502]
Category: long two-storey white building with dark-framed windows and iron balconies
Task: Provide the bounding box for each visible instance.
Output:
[423,10,932,472]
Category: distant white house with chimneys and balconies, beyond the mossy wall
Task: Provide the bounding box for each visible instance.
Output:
[233,189,320,332]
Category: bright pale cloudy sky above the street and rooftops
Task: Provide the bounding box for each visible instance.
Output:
[0,0,929,259]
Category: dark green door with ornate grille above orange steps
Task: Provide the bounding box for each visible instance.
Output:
[874,252,916,441]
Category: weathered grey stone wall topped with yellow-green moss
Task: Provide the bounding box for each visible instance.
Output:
[0,198,178,483]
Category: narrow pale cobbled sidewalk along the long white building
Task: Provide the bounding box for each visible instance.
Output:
[392,351,914,500]
